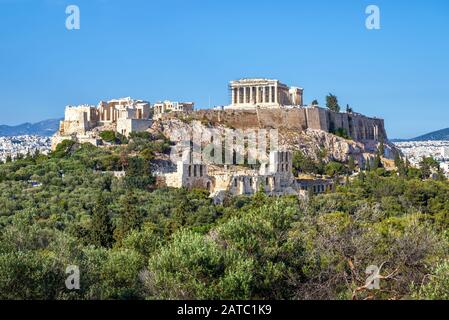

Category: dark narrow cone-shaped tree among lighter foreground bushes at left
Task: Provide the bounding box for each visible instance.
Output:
[89,193,113,248]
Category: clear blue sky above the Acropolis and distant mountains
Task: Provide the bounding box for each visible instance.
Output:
[0,0,449,137]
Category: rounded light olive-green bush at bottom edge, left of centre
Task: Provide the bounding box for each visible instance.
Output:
[144,230,254,299]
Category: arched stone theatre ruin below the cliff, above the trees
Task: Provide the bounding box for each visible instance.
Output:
[160,151,335,203]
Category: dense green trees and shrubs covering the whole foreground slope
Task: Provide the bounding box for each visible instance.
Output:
[0,134,449,299]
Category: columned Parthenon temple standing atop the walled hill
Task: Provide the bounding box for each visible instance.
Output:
[225,79,304,109]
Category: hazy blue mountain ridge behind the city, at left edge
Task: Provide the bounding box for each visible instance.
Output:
[0,119,61,137]
